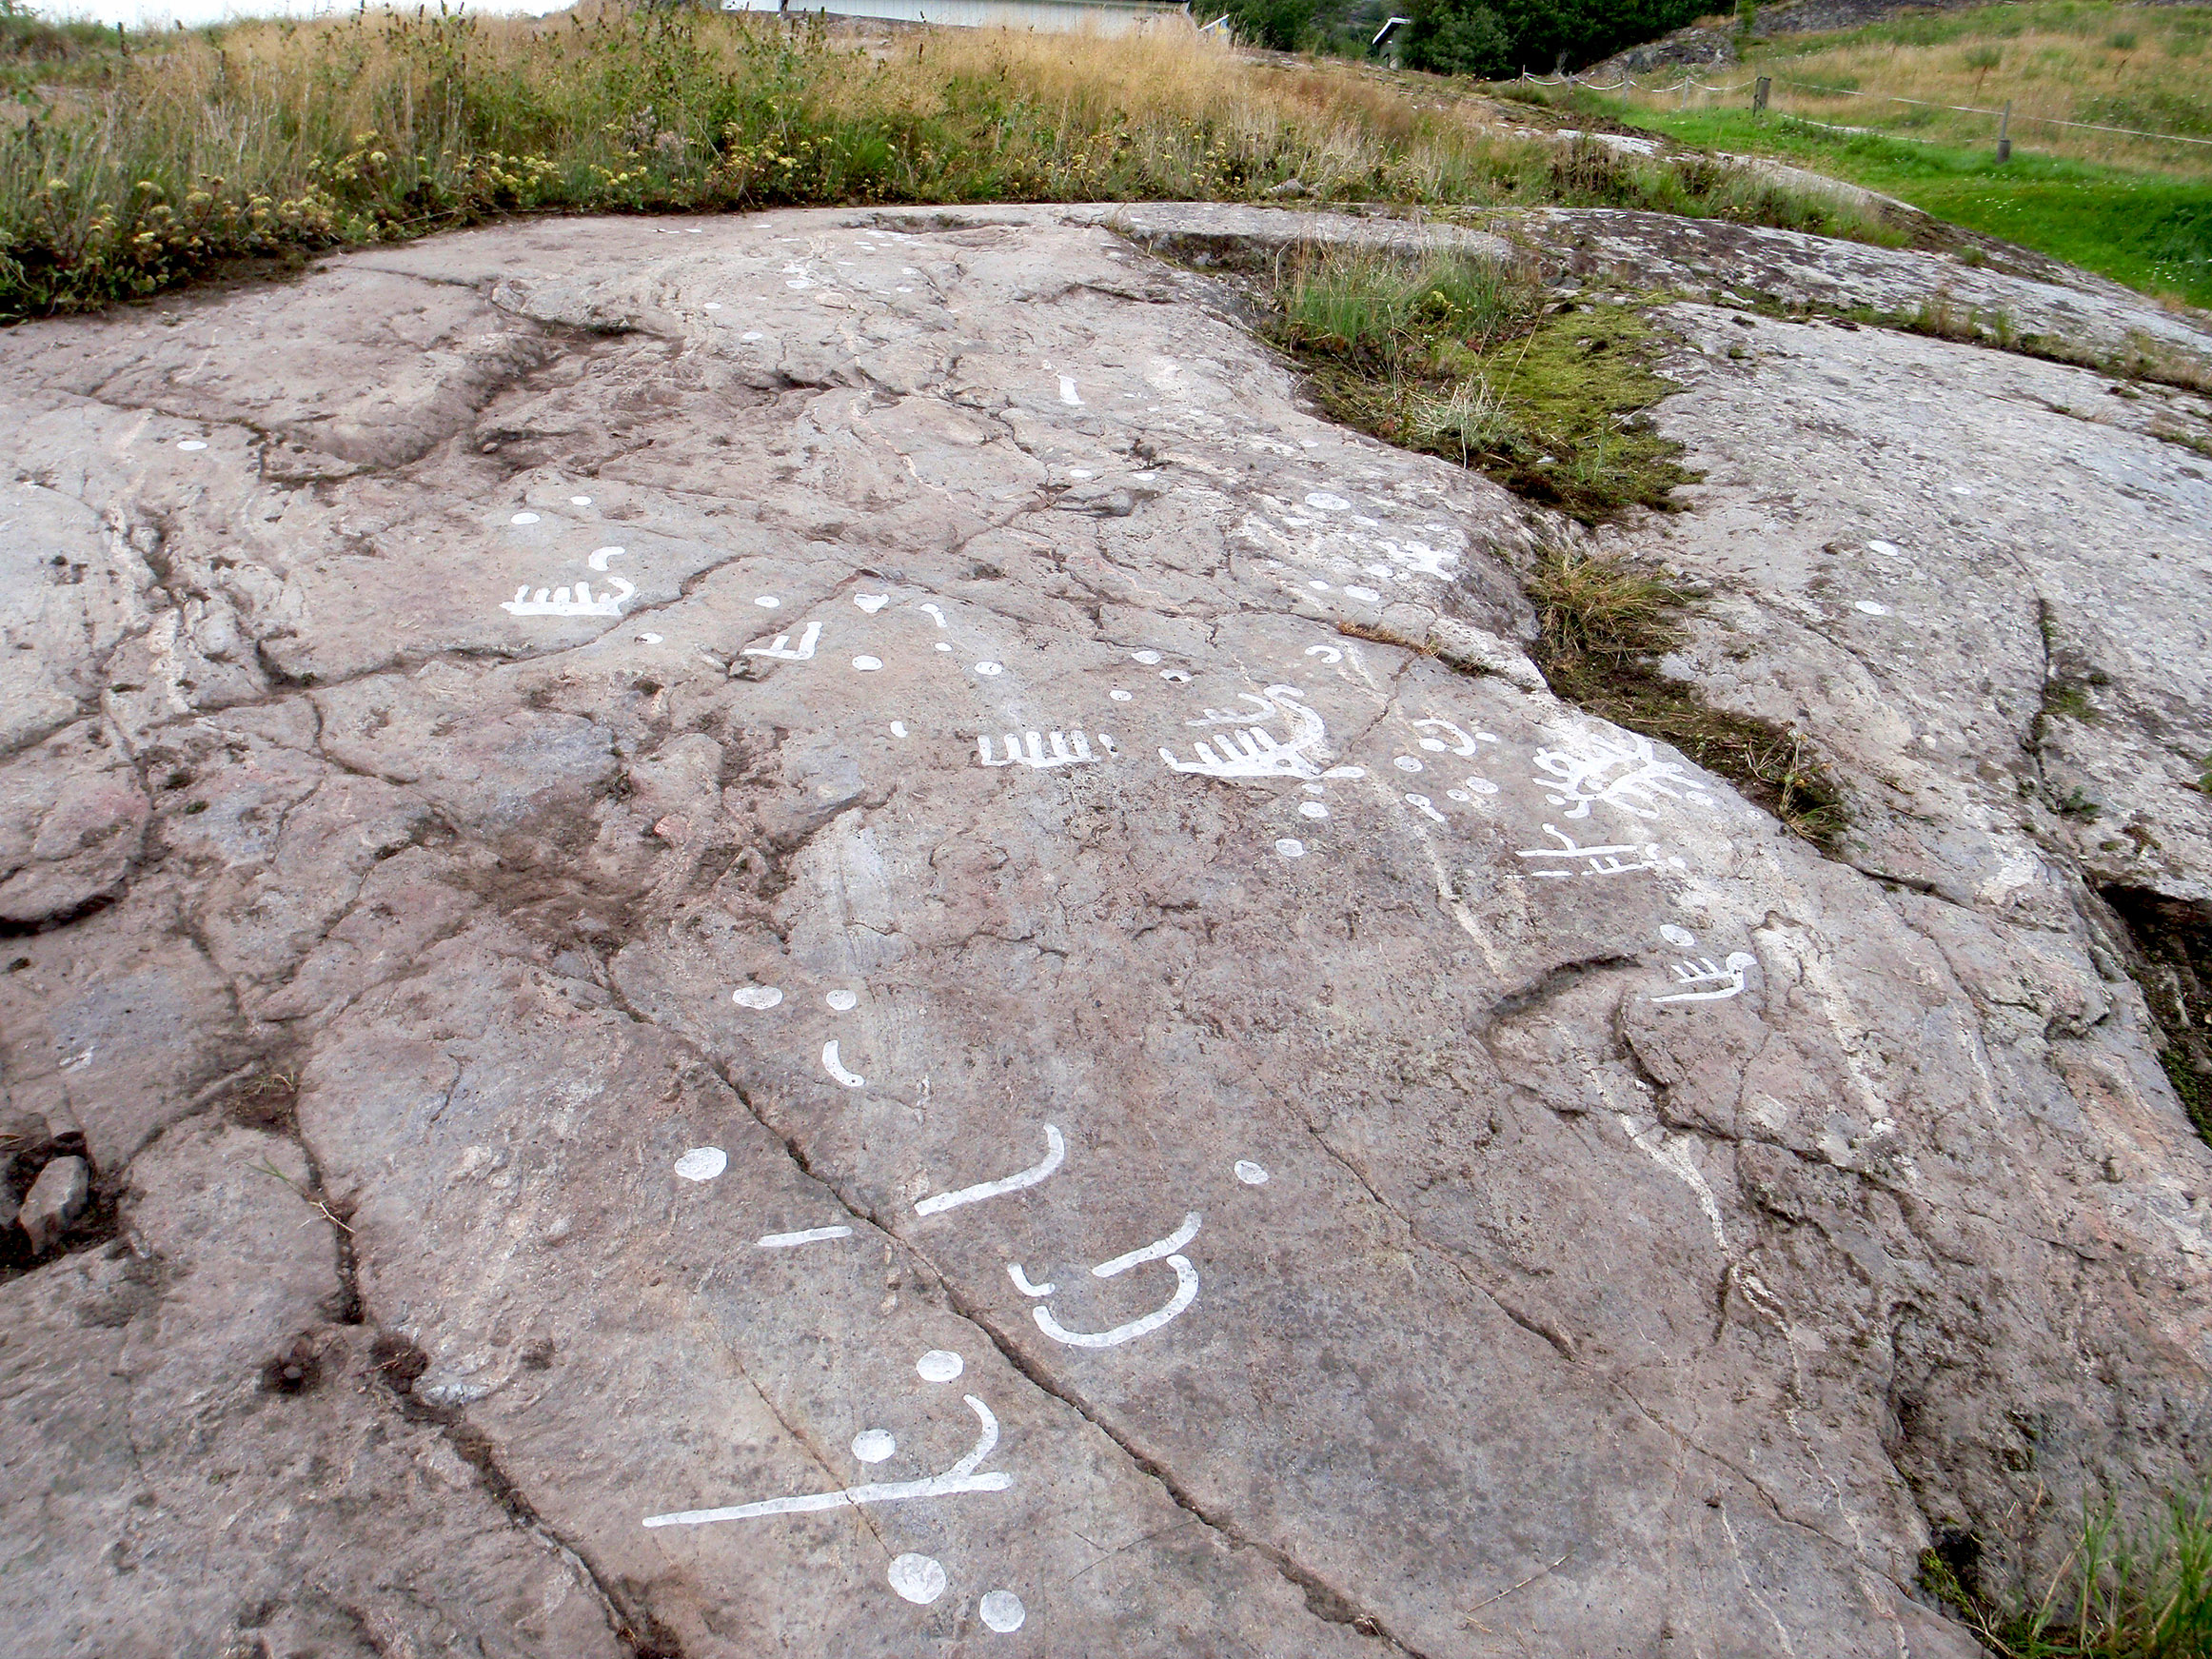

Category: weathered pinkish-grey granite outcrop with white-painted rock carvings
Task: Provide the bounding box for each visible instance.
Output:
[0,207,2212,1659]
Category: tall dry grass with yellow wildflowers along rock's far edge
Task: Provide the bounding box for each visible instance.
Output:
[0,5,1885,319]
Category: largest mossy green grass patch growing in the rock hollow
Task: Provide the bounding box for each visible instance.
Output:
[1274,247,1690,522]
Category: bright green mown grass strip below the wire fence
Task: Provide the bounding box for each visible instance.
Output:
[1584,93,2212,307]
